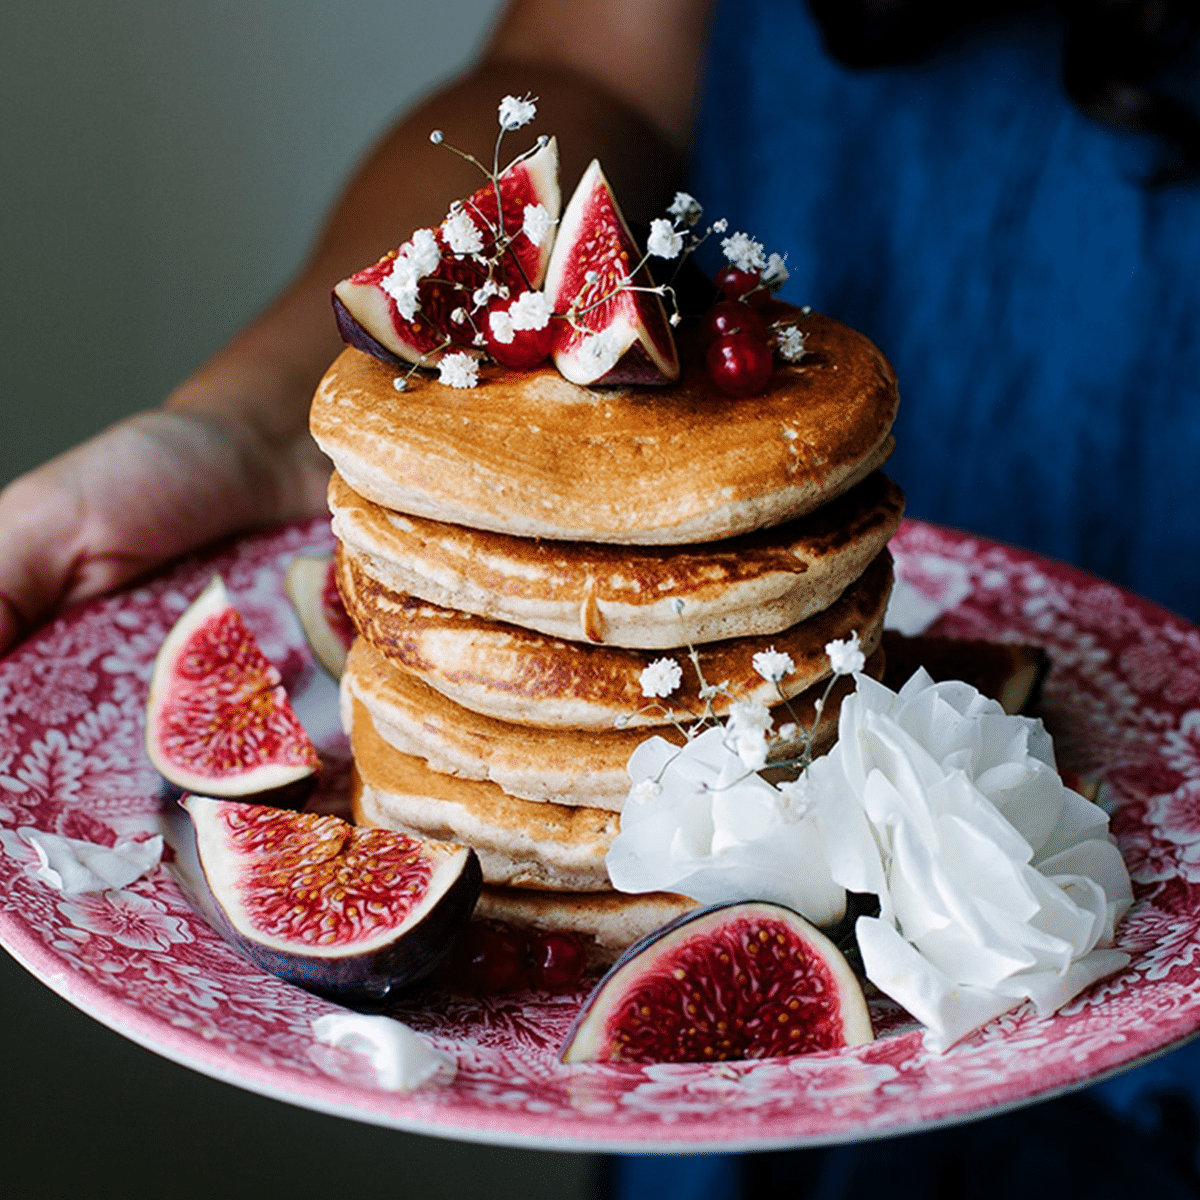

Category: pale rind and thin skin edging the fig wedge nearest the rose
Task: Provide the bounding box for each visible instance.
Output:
[559,900,874,1063]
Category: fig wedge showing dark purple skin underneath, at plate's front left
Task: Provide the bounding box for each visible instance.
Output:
[180,796,482,1003]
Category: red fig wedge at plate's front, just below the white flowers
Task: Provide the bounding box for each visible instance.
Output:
[562,900,874,1063]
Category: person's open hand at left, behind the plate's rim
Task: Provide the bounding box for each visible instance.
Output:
[0,410,329,653]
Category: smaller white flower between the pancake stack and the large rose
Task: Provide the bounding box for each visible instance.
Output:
[606,722,846,925]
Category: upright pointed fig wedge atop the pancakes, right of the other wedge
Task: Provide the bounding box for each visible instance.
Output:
[545,158,679,386]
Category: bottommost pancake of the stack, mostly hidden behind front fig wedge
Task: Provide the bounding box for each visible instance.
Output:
[475,883,698,967]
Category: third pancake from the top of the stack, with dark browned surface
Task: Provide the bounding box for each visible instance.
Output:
[337,547,892,730]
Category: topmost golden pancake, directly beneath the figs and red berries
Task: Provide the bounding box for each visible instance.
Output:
[310,304,899,545]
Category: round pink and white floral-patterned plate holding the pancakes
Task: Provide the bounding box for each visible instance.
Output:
[0,521,1200,1152]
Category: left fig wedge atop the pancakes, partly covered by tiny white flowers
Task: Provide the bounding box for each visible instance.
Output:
[334,138,562,366]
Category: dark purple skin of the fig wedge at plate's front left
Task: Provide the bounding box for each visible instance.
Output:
[180,797,484,1008]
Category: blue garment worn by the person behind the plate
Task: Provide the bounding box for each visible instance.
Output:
[612,0,1200,1200]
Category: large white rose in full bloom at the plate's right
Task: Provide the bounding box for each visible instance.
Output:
[805,671,1133,1050]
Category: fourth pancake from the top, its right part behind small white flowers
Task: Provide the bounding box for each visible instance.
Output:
[342,637,883,812]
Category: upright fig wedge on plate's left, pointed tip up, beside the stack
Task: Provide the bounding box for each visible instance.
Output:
[146,576,320,808]
